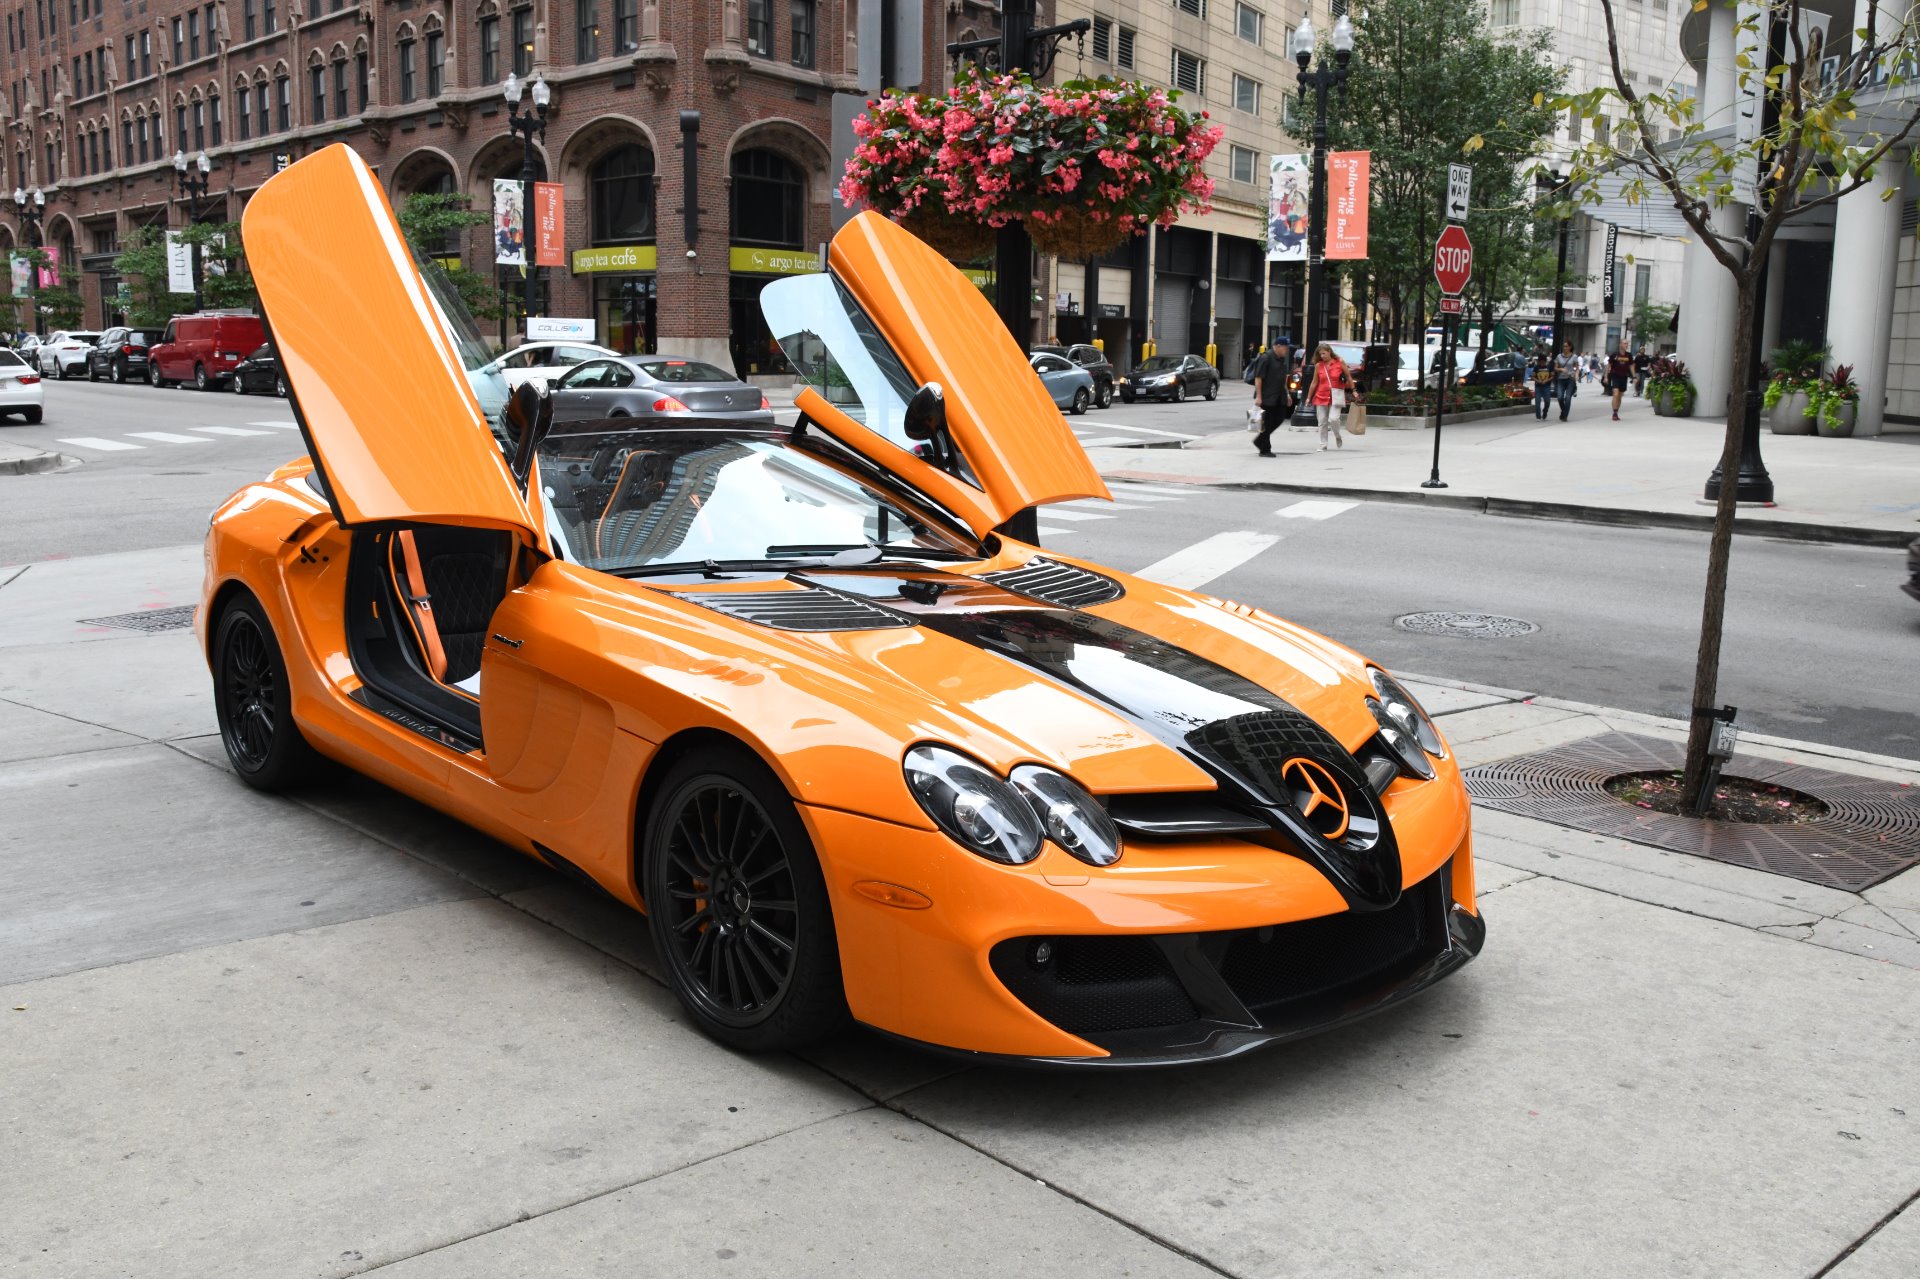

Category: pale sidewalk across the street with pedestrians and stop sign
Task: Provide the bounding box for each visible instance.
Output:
[1089,388,1920,547]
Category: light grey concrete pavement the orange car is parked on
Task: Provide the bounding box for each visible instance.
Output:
[0,533,1920,1279]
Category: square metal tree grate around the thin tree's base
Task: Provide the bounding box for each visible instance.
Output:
[1465,734,1920,893]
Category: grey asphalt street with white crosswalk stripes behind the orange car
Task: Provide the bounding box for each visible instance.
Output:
[0,382,1920,757]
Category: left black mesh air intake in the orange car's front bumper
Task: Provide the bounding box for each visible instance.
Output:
[989,937,1194,1035]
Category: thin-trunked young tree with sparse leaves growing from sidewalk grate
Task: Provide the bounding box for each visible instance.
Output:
[1536,0,1920,807]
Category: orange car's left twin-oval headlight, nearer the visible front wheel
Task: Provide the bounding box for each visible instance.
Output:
[904,745,1119,866]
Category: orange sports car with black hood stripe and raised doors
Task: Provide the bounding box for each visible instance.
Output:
[198,146,1484,1066]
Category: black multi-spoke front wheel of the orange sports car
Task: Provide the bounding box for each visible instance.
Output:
[641,747,847,1052]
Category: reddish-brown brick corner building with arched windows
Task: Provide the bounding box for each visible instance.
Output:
[0,0,996,373]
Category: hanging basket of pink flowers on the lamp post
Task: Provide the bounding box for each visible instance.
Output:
[841,67,1221,259]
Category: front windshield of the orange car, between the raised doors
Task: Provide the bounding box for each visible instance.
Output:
[540,428,979,576]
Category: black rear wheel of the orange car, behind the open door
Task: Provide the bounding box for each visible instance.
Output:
[213,595,321,791]
